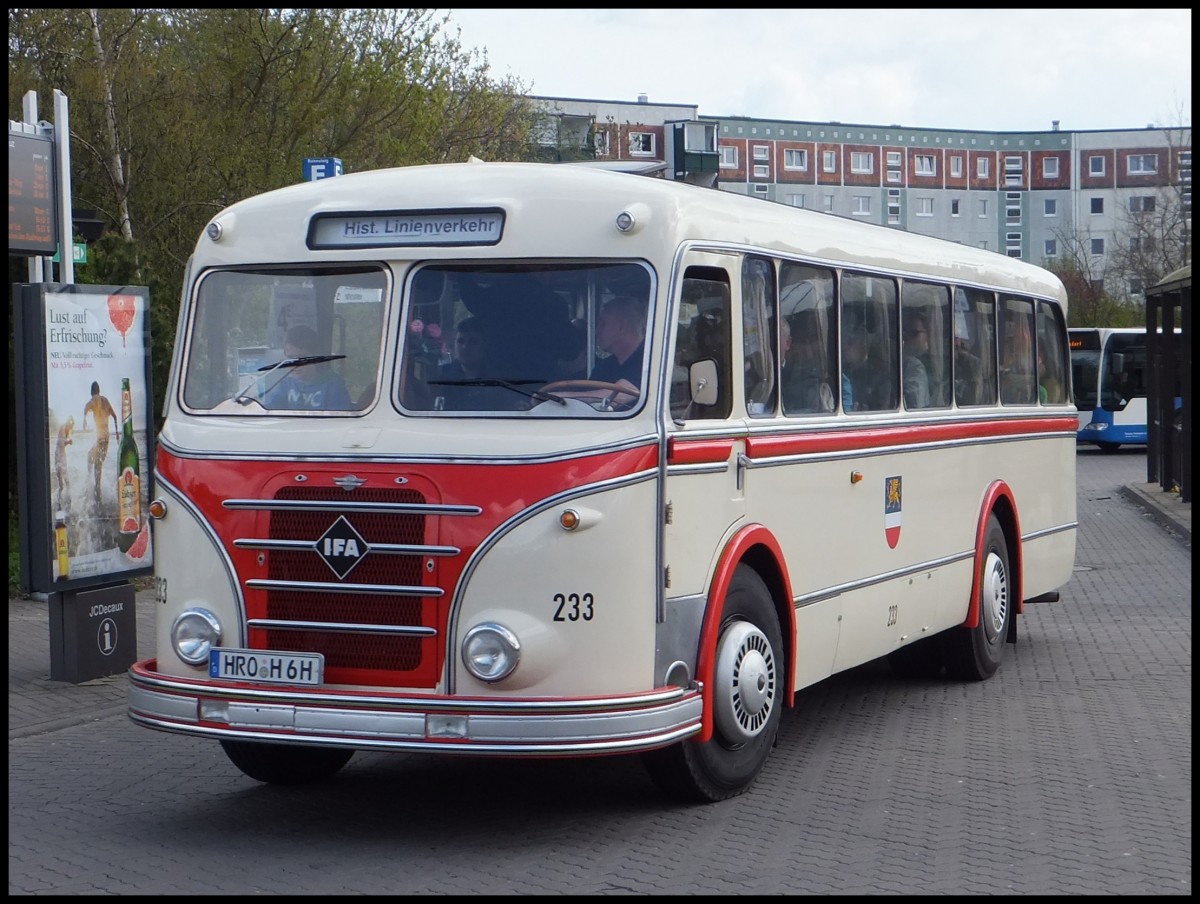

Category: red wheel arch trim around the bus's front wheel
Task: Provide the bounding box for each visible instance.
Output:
[694,525,796,741]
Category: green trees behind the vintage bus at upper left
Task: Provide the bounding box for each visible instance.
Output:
[8,8,535,593]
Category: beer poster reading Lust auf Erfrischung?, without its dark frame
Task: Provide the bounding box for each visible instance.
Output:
[19,283,154,587]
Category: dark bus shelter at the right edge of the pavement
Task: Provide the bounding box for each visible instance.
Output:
[1146,264,1192,502]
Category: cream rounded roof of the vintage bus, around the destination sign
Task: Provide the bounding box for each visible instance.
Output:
[196,162,1067,309]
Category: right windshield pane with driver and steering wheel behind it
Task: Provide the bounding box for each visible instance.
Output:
[400,263,652,417]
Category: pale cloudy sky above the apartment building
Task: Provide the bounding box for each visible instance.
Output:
[439,7,1192,132]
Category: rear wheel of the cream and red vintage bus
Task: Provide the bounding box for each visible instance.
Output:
[942,515,1014,681]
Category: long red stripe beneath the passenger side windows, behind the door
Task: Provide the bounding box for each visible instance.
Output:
[745,415,1078,459]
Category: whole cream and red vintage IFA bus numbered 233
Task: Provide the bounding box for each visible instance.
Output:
[130,162,1076,801]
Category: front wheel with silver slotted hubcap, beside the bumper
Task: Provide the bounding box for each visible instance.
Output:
[643,565,784,803]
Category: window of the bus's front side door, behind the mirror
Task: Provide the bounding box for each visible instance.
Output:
[671,267,733,420]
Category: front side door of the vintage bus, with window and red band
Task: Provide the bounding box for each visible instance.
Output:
[662,252,745,666]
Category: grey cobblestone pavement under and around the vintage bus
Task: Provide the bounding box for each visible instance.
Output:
[8,450,1192,894]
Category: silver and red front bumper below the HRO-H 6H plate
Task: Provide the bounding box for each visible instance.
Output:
[128,659,703,756]
